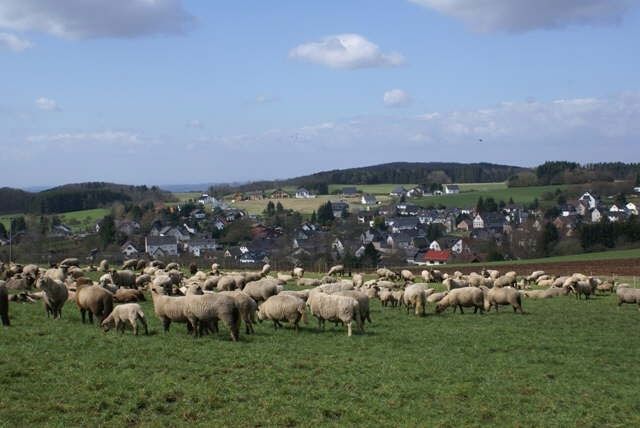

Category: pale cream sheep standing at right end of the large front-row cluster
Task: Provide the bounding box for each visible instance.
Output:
[307,291,364,337]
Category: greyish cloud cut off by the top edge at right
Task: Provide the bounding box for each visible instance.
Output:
[409,0,635,32]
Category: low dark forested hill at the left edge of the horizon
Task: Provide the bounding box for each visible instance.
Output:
[0,182,172,214]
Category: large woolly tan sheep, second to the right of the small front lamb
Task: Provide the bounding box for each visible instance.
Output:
[184,293,240,342]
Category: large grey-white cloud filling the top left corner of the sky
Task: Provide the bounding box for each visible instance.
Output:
[0,0,193,39]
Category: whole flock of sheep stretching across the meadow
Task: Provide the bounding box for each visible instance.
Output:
[0,259,640,341]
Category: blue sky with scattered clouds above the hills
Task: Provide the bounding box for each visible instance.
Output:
[0,0,640,187]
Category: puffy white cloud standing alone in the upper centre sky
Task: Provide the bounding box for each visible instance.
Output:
[289,34,404,69]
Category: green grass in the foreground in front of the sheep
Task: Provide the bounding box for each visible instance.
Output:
[0,282,640,426]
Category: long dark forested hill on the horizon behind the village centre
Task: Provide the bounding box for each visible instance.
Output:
[208,162,527,191]
